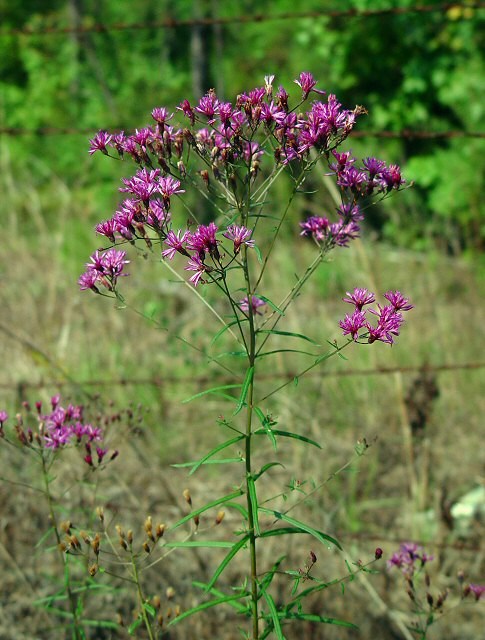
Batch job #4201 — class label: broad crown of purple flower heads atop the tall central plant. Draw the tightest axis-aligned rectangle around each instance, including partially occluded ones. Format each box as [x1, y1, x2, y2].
[86, 72, 404, 291]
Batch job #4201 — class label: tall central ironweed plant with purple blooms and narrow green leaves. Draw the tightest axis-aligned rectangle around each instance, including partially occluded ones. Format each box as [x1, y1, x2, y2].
[79, 72, 412, 640]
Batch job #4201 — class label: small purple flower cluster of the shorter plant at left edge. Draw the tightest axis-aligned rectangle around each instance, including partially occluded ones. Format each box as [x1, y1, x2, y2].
[0, 395, 118, 467]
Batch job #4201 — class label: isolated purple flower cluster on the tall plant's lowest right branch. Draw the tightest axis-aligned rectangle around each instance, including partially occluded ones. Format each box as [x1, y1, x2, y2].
[339, 288, 413, 345]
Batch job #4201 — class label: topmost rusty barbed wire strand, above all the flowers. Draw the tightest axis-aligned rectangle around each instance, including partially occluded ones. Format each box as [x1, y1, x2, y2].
[0, 2, 485, 36]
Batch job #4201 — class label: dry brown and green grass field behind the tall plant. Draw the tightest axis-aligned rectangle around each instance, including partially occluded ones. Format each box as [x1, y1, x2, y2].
[0, 203, 485, 640]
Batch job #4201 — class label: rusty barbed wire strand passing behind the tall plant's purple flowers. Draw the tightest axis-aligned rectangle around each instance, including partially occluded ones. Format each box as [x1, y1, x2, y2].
[0, 126, 485, 140]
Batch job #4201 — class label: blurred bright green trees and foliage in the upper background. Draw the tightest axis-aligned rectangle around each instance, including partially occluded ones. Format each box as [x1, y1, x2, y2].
[0, 0, 485, 254]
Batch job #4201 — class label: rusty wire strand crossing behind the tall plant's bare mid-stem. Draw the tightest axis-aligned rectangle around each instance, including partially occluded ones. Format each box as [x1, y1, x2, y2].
[0, 362, 485, 390]
